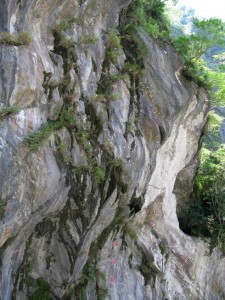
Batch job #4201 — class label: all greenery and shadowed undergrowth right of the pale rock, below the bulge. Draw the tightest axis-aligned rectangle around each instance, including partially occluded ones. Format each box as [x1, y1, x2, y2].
[180, 112, 225, 252]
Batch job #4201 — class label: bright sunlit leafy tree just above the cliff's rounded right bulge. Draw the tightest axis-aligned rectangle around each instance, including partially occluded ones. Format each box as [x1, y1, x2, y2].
[173, 14, 225, 106]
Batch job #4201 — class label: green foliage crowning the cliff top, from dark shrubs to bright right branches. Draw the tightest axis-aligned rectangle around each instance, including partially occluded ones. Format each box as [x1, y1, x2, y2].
[125, 0, 225, 106]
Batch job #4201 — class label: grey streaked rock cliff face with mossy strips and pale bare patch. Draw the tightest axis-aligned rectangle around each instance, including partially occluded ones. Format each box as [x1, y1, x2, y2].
[0, 0, 225, 300]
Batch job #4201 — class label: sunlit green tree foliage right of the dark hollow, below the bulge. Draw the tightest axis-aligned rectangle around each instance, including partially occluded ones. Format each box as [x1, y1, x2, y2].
[194, 146, 225, 251]
